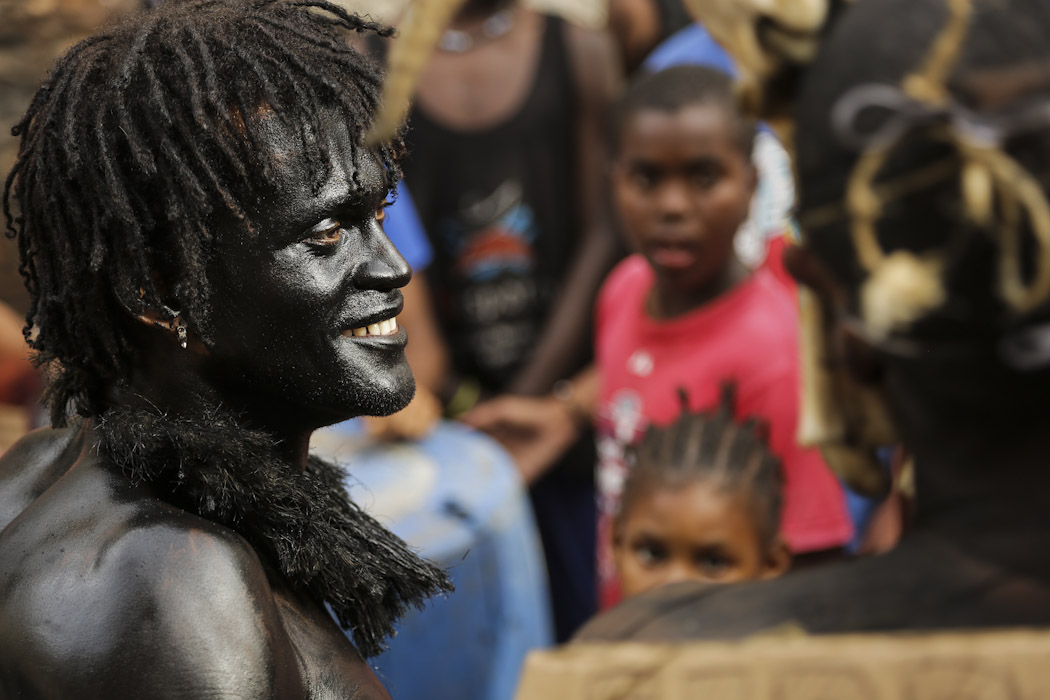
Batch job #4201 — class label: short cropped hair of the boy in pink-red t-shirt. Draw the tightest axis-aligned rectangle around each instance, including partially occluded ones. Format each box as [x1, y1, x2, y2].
[609, 65, 757, 157]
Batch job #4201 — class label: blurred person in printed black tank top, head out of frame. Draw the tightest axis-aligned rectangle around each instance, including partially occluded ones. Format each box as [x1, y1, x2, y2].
[394, 0, 618, 640]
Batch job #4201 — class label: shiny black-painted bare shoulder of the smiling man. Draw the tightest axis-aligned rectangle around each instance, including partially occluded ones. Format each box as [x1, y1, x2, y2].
[0, 464, 307, 700]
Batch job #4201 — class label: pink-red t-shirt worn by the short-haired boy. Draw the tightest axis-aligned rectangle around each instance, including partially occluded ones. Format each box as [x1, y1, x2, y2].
[595, 255, 853, 603]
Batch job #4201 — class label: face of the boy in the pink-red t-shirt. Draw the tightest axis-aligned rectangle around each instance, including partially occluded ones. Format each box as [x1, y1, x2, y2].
[613, 104, 755, 294]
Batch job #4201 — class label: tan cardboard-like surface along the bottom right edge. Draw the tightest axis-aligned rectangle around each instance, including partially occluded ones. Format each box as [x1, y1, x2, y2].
[516, 631, 1050, 700]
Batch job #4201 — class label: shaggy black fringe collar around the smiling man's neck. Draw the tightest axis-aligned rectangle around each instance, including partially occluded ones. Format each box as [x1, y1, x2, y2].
[96, 398, 452, 657]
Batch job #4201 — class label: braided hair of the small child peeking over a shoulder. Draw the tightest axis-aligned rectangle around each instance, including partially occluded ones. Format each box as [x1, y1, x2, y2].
[620, 381, 783, 545]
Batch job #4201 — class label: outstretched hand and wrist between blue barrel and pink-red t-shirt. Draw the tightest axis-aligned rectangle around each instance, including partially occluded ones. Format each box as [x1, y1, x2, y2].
[462, 365, 599, 484]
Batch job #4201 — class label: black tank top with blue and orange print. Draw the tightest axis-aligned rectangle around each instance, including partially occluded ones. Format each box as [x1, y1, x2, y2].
[404, 17, 580, 391]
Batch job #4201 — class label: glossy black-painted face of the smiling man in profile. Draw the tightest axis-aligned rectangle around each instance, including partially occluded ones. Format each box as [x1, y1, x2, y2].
[206, 110, 415, 428]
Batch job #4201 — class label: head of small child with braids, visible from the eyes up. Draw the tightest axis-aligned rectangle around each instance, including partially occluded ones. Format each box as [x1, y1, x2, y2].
[613, 382, 791, 598]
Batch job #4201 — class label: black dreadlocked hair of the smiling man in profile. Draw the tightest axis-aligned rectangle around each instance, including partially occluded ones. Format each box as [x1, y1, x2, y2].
[3, 0, 403, 425]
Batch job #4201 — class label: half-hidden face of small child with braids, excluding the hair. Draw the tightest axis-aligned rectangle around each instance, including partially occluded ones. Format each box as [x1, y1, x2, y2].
[613, 481, 791, 598]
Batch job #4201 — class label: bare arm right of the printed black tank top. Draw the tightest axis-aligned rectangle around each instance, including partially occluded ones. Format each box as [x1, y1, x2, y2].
[507, 25, 622, 396]
